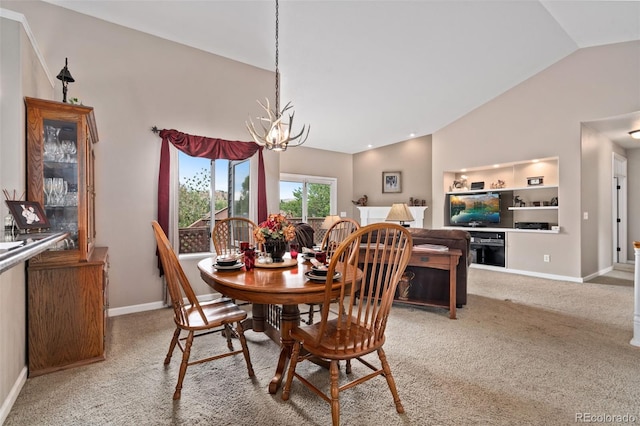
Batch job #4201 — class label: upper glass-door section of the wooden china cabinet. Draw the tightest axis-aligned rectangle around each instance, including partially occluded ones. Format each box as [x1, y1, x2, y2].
[25, 98, 97, 262]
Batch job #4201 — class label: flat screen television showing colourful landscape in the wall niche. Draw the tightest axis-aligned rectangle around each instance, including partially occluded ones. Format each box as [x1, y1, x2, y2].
[449, 192, 500, 226]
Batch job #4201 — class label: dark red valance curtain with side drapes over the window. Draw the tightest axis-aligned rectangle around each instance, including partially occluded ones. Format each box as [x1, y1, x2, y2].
[158, 129, 267, 241]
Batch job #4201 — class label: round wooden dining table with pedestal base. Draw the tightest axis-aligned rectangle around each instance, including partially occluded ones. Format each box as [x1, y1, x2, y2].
[198, 257, 362, 394]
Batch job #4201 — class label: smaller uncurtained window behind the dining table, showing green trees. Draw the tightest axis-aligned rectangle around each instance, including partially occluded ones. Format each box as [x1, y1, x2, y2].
[280, 173, 338, 242]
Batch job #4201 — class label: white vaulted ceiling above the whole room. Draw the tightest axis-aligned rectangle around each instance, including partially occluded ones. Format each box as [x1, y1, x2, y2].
[41, 0, 640, 153]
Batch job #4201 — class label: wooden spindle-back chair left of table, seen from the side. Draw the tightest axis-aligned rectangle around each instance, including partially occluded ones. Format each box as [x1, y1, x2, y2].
[152, 221, 254, 399]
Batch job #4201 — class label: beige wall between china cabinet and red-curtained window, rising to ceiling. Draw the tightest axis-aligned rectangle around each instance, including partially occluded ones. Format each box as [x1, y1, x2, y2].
[3, 1, 278, 309]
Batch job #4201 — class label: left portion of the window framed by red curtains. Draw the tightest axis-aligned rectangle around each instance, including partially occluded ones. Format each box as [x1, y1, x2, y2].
[177, 151, 230, 254]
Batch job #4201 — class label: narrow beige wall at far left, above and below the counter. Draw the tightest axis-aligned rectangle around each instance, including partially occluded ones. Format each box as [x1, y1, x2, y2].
[0, 11, 53, 423]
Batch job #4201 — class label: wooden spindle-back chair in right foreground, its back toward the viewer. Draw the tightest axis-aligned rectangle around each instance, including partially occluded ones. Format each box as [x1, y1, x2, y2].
[282, 223, 412, 426]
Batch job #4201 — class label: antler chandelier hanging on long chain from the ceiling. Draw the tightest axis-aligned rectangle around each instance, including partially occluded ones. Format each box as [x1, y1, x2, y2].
[246, 0, 311, 151]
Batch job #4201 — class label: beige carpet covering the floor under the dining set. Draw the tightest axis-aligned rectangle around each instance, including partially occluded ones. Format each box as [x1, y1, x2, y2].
[6, 269, 640, 426]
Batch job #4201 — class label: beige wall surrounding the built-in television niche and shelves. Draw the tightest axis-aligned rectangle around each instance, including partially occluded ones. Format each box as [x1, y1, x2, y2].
[433, 42, 640, 279]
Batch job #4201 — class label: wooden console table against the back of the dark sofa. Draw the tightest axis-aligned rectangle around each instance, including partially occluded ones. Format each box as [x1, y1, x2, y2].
[394, 247, 462, 319]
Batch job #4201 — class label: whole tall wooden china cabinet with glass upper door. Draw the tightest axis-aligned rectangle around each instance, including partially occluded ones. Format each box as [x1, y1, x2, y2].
[25, 98, 109, 377]
